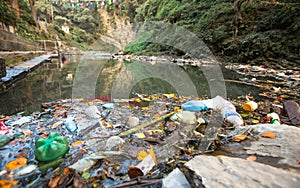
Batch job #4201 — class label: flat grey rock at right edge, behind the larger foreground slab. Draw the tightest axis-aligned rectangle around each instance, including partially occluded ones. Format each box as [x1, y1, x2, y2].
[243, 124, 300, 168]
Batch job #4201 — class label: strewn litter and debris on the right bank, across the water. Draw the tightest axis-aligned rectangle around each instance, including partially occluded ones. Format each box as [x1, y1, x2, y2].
[226, 64, 300, 100]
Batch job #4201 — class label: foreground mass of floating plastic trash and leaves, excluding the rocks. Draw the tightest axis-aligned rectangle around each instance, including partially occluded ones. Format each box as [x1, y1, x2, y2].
[0, 94, 300, 187]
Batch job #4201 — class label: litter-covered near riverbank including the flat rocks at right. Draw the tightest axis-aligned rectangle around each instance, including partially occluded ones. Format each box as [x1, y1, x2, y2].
[0, 94, 300, 187]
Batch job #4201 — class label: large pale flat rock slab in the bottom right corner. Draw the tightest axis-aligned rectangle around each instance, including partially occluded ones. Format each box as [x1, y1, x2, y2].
[184, 155, 300, 188]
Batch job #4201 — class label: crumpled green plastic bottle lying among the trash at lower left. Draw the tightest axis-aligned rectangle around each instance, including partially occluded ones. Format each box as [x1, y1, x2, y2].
[35, 132, 69, 162]
